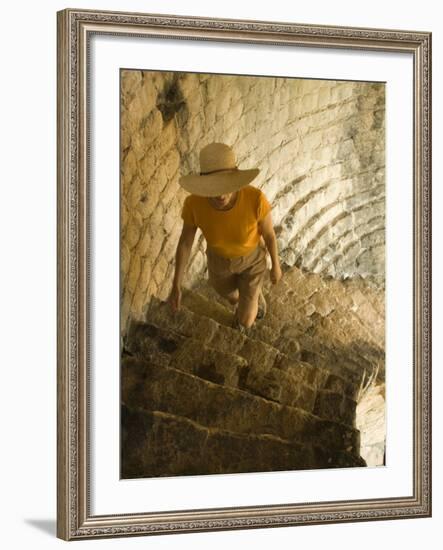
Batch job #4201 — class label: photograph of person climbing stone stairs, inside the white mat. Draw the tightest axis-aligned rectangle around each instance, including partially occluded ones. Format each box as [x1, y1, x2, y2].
[120, 68, 389, 479]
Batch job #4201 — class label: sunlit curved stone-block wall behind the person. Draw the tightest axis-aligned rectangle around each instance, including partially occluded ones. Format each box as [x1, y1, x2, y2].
[121, 70, 385, 334]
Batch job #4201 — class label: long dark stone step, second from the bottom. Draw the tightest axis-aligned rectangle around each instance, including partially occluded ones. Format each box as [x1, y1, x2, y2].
[122, 357, 360, 455]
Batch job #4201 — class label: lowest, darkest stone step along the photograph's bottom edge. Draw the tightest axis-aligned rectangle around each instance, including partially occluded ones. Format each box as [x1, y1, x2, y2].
[121, 406, 365, 479]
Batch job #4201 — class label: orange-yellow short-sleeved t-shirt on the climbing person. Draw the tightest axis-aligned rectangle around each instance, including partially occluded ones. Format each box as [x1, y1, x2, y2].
[182, 185, 271, 258]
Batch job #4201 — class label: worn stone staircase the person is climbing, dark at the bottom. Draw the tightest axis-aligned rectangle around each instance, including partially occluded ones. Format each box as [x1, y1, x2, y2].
[121, 268, 384, 478]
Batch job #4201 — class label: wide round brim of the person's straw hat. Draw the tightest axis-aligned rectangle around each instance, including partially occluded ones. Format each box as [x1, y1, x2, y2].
[179, 168, 260, 201]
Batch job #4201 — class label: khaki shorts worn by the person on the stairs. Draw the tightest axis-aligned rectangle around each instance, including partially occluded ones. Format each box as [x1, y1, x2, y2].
[206, 245, 266, 299]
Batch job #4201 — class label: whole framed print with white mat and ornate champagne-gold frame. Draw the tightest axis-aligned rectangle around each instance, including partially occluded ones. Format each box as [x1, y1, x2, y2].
[58, 9, 431, 540]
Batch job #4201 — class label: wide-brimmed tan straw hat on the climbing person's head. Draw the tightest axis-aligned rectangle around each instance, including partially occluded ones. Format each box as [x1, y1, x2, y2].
[179, 143, 260, 197]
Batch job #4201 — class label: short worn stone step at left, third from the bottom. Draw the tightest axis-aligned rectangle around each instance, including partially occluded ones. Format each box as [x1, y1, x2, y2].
[125, 321, 248, 388]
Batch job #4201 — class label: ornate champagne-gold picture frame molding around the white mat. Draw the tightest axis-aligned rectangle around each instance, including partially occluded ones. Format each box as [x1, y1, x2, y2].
[57, 9, 431, 540]
